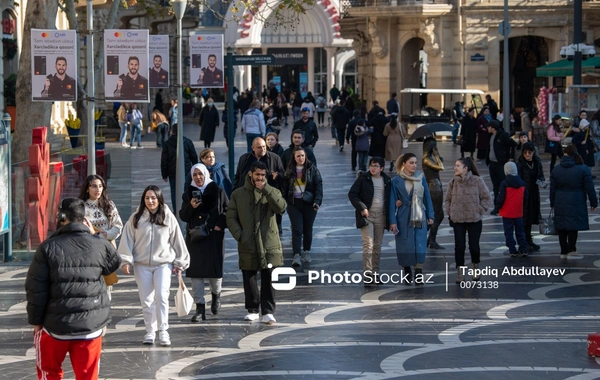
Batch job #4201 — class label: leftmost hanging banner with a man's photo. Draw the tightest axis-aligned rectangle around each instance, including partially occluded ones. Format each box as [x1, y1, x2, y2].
[31, 29, 77, 102]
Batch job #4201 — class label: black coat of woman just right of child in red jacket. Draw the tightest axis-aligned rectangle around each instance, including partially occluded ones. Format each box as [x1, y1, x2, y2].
[517, 155, 546, 225]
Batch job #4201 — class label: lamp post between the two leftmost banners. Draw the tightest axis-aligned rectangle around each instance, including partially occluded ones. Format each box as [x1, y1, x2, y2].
[87, 0, 96, 175]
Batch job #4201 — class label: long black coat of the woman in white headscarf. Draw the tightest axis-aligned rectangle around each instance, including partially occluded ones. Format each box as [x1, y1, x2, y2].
[179, 182, 229, 278]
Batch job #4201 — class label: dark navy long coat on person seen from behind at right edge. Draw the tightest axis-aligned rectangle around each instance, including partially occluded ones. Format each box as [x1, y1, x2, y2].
[550, 156, 598, 231]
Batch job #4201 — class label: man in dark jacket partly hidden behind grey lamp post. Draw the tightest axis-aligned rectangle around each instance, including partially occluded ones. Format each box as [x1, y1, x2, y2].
[160, 124, 198, 212]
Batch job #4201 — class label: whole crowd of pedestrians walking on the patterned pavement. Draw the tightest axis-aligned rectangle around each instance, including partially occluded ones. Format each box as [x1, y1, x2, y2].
[26, 87, 600, 375]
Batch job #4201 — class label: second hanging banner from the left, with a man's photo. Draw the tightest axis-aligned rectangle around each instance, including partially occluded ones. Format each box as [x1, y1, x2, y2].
[104, 29, 150, 103]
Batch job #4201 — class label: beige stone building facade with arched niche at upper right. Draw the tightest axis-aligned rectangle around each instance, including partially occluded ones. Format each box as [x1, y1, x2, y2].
[340, 0, 600, 114]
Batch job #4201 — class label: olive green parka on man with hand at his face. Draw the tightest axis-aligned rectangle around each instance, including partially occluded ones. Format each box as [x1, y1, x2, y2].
[227, 176, 287, 270]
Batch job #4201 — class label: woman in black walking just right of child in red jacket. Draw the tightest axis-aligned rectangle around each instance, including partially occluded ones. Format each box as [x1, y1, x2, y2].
[517, 142, 546, 251]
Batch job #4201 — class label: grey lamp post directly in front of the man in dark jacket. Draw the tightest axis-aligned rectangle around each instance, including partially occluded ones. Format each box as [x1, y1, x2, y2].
[171, 0, 187, 222]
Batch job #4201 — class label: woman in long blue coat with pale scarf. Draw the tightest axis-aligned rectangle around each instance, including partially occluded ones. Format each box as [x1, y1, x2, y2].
[388, 153, 434, 285]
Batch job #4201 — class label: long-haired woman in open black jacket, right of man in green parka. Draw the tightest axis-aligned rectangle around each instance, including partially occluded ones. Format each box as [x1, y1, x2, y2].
[282, 147, 323, 267]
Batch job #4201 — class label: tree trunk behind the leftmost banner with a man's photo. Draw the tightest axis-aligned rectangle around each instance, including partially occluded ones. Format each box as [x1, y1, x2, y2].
[12, 0, 58, 162]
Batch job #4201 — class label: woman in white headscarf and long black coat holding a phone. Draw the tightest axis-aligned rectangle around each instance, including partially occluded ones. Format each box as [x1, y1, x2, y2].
[179, 164, 229, 322]
